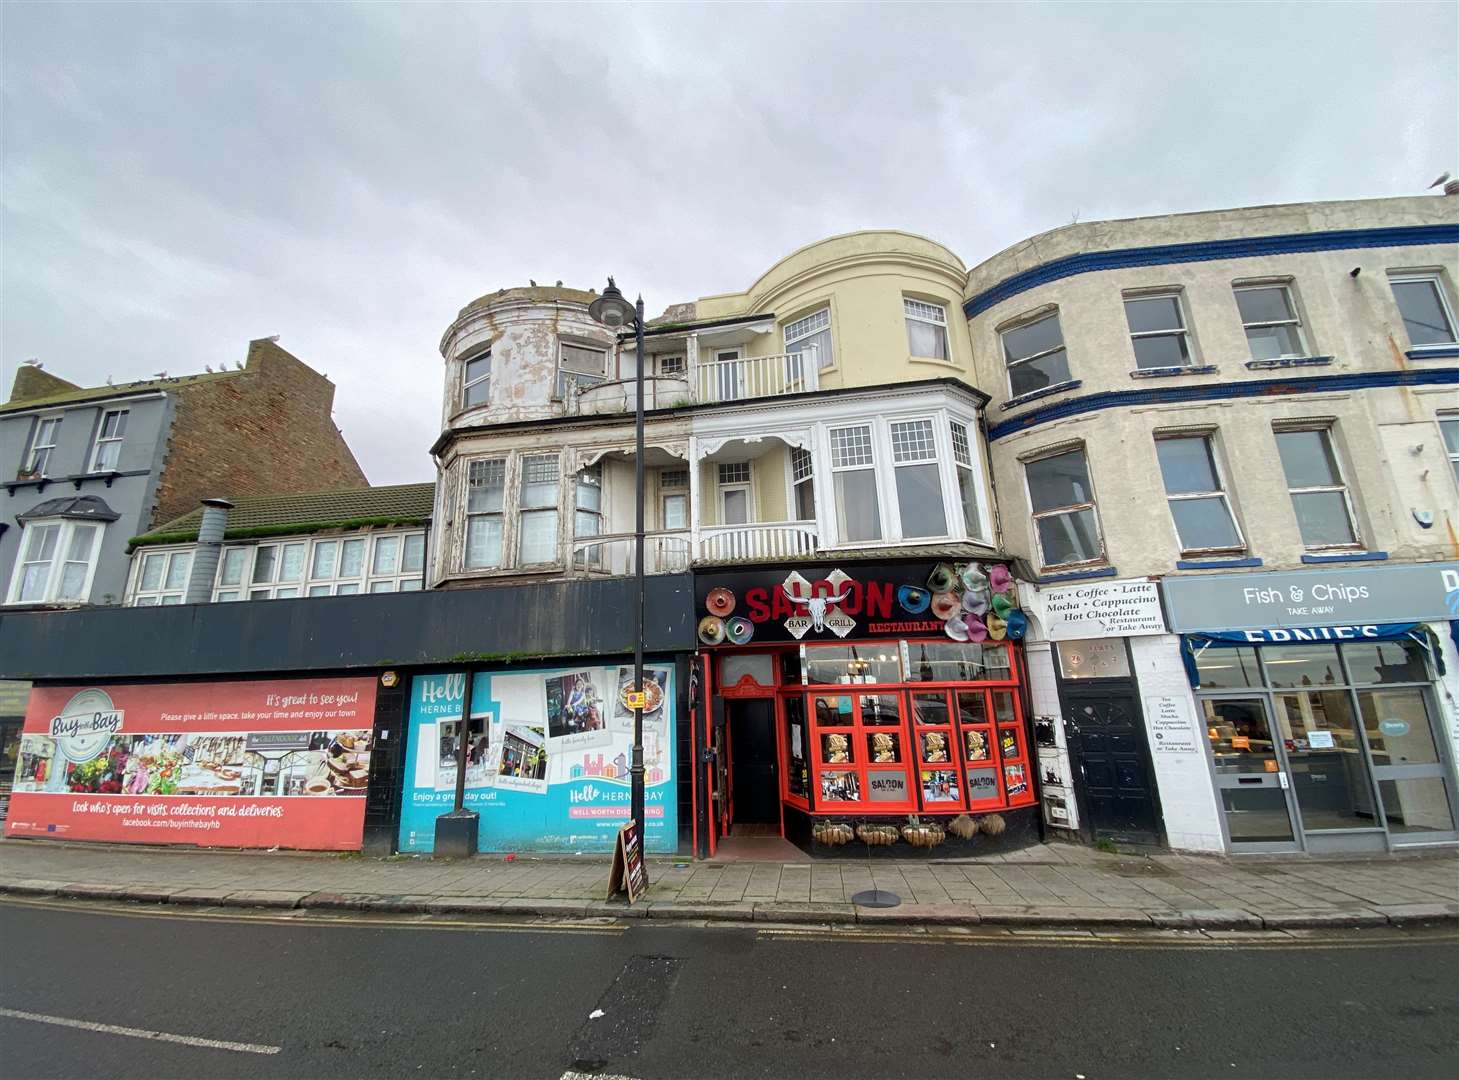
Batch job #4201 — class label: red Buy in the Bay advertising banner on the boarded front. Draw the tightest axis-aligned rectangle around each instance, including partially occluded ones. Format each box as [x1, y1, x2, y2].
[4, 679, 375, 851]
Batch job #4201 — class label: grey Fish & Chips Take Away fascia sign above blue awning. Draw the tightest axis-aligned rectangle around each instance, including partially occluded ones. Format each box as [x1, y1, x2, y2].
[1161, 562, 1459, 633]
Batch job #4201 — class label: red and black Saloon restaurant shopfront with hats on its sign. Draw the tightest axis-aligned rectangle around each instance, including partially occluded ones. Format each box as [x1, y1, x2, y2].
[696, 562, 1039, 857]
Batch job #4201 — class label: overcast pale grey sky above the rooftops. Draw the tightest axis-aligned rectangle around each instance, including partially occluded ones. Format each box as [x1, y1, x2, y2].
[0, 0, 1459, 483]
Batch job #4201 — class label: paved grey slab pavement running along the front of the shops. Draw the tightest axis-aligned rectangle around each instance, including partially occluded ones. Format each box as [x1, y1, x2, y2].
[0, 839, 1459, 930]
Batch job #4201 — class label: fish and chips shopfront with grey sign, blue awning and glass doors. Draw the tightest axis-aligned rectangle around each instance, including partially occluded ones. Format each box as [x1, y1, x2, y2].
[1164, 563, 1459, 852]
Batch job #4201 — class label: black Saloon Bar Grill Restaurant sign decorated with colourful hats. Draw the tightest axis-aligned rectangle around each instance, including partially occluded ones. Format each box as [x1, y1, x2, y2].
[694, 562, 1027, 645]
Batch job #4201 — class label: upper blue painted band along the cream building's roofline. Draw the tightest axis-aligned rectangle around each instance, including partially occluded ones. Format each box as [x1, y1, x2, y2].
[963, 225, 1459, 318]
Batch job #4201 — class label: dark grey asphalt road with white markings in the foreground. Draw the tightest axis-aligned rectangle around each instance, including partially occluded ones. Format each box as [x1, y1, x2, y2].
[0, 903, 1459, 1080]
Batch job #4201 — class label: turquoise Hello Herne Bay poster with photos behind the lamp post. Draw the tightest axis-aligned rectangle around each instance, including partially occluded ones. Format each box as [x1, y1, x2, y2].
[400, 664, 678, 854]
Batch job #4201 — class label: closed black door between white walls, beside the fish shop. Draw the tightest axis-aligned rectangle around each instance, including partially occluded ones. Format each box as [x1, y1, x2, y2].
[1059, 679, 1160, 844]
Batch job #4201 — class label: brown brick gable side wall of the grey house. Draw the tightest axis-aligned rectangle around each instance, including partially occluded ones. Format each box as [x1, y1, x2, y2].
[152, 340, 369, 525]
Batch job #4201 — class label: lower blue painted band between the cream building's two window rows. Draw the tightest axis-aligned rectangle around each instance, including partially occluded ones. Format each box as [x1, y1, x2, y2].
[988, 368, 1459, 442]
